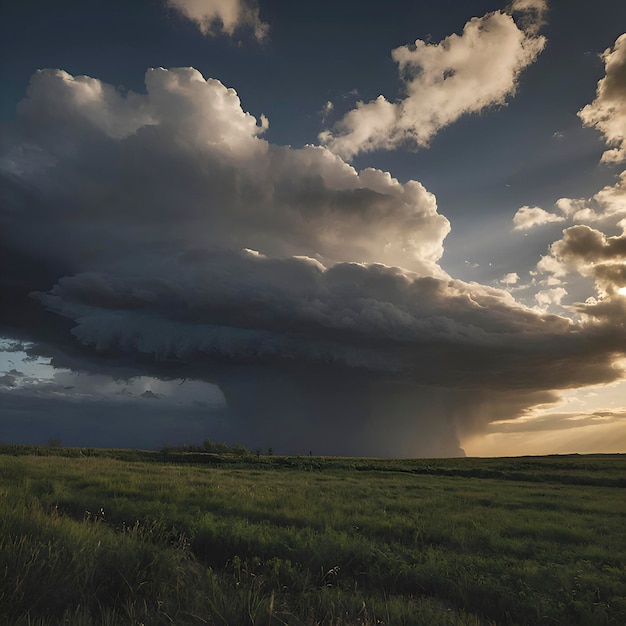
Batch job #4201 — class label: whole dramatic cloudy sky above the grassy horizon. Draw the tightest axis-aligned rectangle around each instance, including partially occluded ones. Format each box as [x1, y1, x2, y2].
[0, 0, 626, 457]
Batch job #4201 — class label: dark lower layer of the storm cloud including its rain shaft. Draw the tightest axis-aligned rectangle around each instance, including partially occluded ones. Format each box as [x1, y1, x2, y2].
[22, 253, 620, 456]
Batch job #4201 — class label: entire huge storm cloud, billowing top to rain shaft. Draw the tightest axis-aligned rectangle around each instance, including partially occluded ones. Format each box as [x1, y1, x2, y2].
[0, 62, 626, 456]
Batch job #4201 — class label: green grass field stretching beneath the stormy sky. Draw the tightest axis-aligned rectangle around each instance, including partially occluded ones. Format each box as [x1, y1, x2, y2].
[0, 446, 626, 626]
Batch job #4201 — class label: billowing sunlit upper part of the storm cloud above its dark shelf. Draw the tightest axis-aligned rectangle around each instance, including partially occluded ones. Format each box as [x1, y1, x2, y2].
[2, 68, 450, 275]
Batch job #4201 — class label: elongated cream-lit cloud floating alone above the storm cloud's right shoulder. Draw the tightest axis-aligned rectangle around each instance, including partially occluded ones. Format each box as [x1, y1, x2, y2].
[319, 7, 545, 159]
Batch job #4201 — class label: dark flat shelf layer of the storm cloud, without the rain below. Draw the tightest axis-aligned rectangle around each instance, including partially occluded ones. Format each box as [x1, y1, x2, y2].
[33, 252, 588, 378]
